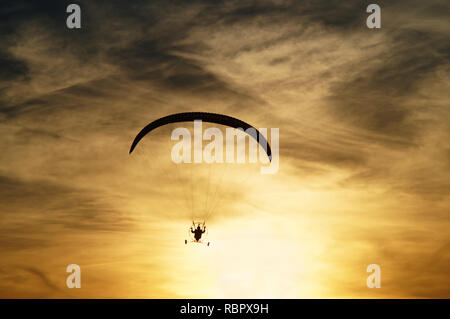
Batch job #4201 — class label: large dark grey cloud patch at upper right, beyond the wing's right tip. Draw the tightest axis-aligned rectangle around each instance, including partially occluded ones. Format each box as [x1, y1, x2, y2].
[329, 10, 450, 146]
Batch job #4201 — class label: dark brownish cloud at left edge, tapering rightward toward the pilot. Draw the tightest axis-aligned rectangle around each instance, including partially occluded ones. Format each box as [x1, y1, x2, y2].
[0, 176, 134, 236]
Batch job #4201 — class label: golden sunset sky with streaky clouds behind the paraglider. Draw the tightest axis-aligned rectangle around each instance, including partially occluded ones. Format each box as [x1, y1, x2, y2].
[0, 0, 450, 298]
